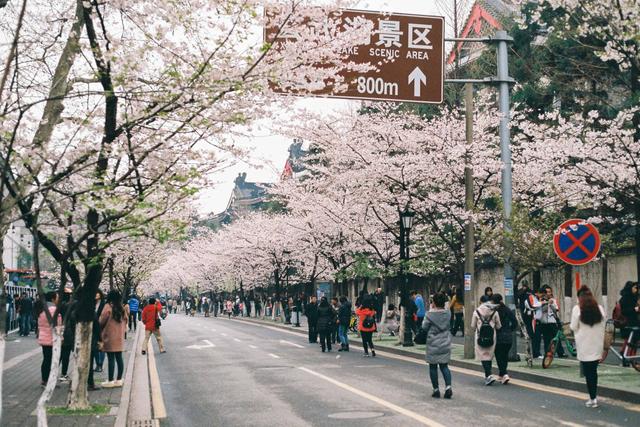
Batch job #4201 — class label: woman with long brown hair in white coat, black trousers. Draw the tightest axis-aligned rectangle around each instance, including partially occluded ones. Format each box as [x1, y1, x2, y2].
[570, 286, 606, 408]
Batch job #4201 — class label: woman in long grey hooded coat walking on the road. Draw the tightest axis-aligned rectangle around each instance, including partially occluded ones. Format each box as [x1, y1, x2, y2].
[421, 292, 453, 399]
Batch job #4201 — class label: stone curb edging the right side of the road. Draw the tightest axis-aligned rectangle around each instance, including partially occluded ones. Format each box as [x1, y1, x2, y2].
[232, 317, 640, 403]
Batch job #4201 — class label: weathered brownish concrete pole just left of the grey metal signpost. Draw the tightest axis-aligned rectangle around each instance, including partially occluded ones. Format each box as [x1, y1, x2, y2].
[463, 83, 476, 359]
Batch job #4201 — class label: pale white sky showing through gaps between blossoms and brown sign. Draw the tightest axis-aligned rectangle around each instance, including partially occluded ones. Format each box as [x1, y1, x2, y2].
[198, 0, 452, 215]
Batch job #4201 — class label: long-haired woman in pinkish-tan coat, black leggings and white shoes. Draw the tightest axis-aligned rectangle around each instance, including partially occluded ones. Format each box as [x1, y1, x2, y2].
[100, 290, 128, 388]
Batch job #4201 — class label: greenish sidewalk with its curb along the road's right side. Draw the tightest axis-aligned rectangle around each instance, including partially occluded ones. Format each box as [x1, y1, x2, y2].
[228, 317, 640, 403]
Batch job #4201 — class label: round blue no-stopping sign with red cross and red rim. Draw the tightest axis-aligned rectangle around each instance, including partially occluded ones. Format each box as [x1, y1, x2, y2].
[553, 219, 600, 265]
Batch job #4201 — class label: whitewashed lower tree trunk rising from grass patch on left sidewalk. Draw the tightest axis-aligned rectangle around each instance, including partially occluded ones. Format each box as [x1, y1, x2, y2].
[67, 322, 93, 409]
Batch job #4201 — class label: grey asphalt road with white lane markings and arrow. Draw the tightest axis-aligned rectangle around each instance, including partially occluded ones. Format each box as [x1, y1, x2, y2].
[152, 314, 640, 427]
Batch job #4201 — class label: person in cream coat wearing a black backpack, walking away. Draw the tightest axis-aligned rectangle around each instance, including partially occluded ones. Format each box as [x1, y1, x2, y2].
[471, 301, 502, 386]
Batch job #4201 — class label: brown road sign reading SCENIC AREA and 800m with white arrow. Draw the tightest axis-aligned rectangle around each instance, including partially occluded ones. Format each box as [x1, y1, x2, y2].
[265, 10, 444, 103]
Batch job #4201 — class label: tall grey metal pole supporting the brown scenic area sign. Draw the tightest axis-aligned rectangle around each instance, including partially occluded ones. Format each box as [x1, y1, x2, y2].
[495, 31, 517, 360]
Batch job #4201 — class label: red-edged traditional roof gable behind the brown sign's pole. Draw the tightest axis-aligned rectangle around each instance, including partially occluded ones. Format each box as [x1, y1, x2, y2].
[447, 0, 519, 65]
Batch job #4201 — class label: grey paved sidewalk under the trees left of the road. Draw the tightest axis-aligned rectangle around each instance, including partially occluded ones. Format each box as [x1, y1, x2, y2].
[2, 326, 141, 427]
